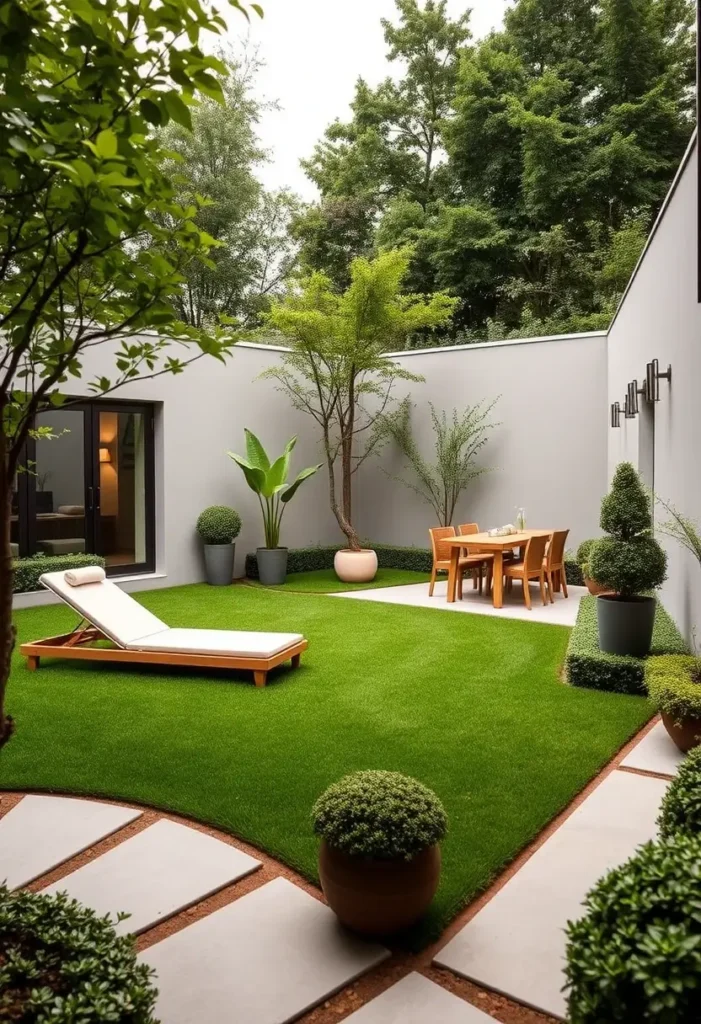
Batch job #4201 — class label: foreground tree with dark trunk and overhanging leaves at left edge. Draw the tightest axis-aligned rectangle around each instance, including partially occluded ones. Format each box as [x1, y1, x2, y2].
[0, 0, 261, 742]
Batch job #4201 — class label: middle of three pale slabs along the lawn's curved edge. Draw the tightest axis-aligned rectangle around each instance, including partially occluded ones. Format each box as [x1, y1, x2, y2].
[44, 818, 261, 935]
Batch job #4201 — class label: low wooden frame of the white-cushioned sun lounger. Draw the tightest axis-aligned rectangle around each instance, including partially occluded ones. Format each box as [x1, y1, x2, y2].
[19, 573, 308, 686]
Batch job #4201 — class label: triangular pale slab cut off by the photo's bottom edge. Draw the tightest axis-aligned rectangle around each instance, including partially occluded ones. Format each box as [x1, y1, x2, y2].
[344, 974, 494, 1024]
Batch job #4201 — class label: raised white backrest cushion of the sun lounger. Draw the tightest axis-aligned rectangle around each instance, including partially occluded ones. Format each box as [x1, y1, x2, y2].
[39, 572, 168, 647]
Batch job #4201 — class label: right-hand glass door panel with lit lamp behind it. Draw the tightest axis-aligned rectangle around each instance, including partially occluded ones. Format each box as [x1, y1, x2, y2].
[95, 406, 152, 572]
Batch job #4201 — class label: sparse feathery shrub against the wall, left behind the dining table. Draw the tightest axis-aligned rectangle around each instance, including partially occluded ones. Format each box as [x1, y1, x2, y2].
[381, 398, 498, 526]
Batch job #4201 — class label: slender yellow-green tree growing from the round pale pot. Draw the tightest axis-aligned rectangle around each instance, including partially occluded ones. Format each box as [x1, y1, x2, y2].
[264, 250, 454, 551]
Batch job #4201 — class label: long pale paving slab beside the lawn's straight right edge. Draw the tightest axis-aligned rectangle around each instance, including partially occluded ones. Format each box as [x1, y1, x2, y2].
[435, 771, 668, 1019]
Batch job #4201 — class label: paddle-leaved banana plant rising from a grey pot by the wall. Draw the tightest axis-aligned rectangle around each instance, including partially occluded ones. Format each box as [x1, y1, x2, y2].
[226, 428, 321, 548]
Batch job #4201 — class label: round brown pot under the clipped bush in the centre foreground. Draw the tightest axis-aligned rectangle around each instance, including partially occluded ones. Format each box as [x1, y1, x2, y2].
[319, 840, 441, 936]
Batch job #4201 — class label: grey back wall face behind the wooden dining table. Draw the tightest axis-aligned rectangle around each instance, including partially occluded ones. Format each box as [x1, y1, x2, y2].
[356, 334, 607, 548]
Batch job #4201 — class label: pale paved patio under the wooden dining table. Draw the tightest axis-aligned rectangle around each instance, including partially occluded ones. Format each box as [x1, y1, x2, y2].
[330, 580, 589, 628]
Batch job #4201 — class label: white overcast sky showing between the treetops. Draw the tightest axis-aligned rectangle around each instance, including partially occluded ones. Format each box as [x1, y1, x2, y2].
[220, 0, 508, 200]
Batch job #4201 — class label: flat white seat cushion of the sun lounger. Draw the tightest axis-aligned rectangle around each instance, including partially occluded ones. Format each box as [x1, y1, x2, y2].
[127, 629, 304, 658]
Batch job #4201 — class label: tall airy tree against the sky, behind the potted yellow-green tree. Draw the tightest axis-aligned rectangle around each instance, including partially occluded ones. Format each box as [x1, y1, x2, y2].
[297, 0, 470, 287]
